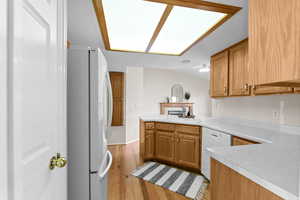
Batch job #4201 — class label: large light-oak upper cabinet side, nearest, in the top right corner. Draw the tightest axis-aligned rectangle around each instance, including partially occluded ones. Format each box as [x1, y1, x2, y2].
[249, 0, 300, 86]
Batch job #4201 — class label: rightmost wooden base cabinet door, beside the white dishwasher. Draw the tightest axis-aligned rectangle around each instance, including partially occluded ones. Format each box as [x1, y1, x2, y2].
[175, 133, 201, 169]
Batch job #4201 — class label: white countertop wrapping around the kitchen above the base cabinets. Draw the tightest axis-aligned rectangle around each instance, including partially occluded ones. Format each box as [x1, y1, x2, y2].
[141, 115, 300, 200]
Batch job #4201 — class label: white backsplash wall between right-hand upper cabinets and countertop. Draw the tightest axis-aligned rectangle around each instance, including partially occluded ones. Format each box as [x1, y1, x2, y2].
[212, 94, 300, 126]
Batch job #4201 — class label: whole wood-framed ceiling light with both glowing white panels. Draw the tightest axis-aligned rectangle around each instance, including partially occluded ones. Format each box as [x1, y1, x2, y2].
[93, 0, 240, 55]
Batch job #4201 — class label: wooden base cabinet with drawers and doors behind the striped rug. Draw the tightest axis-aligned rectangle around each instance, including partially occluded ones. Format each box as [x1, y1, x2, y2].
[140, 121, 202, 171]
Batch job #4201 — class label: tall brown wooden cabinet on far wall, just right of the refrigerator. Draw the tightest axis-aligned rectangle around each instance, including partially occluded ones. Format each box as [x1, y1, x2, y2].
[109, 72, 124, 126]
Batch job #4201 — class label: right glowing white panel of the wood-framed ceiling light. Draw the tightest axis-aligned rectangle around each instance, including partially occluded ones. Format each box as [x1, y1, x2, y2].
[150, 6, 227, 55]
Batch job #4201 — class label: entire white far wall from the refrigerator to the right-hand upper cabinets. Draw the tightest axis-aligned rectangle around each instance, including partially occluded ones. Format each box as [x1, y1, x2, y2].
[108, 67, 211, 144]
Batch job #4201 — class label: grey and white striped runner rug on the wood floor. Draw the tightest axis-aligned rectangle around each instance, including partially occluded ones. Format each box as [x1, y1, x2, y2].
[132, 162, 207, 200]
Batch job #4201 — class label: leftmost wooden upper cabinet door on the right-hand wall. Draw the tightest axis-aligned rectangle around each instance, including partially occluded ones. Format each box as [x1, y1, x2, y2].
[210, 51, 228, 97]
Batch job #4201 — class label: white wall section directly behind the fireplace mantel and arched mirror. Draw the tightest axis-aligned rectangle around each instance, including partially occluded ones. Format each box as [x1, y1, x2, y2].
[142, 68, 211, 118]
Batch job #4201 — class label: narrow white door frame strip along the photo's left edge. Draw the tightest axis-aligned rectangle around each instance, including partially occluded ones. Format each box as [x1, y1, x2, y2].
[0, 0, 8, 200]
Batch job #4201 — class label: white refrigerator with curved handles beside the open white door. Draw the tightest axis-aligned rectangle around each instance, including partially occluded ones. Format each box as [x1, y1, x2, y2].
[67, 47, 112, 200]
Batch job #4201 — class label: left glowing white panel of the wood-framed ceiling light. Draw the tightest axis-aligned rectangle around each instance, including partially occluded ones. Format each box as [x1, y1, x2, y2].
[102, 0, 166, 52]
